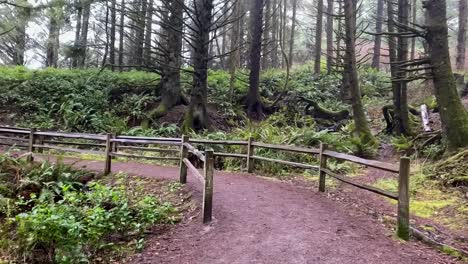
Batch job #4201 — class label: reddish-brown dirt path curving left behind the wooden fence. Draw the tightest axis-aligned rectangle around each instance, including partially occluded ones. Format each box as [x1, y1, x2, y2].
[37, 158, 457, 264]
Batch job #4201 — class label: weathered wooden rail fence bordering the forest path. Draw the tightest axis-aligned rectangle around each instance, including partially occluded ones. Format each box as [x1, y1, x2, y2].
[0, 127, 410, 239]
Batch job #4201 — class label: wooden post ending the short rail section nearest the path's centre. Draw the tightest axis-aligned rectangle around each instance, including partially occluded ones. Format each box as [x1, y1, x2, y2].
[203, 150, 214, 224]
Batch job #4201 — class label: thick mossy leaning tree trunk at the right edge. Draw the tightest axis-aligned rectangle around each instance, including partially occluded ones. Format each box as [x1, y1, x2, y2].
[424, 0, 468, 151]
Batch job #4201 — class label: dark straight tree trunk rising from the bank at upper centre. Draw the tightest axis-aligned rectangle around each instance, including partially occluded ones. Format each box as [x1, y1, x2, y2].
[247, 0, 266, 120]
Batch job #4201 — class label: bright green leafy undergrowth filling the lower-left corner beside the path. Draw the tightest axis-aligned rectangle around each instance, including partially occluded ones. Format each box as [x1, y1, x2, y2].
[0, 153, 178, 263]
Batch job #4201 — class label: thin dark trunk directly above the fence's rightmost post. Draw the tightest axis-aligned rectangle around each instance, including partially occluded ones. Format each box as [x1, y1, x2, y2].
[397, 0, 411, 135]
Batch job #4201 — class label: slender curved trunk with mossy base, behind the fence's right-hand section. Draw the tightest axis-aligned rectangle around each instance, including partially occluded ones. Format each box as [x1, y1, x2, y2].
[344, 0, 376, 145]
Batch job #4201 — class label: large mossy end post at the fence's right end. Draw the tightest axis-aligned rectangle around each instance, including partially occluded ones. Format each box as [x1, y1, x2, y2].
[397, 157, 410, 240]
